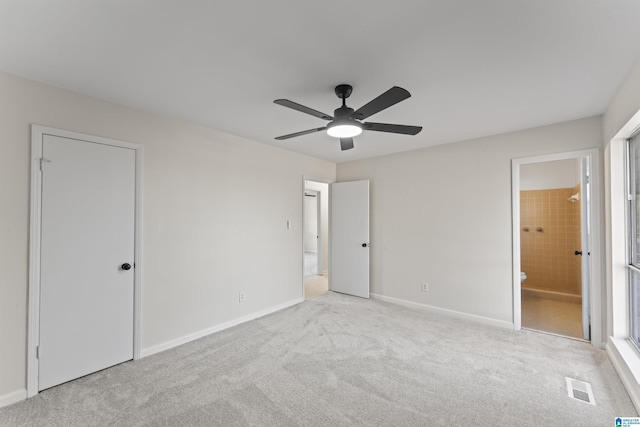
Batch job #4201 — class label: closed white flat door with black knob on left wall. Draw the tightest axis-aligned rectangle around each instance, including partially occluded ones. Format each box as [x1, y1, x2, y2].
[38, 135, 136, 390]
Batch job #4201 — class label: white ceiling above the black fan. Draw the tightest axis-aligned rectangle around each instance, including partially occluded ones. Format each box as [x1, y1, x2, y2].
[0, 0, 640, 163]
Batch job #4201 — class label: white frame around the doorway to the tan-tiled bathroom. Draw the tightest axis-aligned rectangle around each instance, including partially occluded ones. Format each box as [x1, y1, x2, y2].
[511, 148, 604, 348]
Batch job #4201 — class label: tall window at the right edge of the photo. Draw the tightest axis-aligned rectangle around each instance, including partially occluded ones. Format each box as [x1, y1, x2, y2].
[627, 134, 640, 348]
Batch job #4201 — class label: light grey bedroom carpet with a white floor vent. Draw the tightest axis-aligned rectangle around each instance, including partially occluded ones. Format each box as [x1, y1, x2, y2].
[0, 292, 636, 427]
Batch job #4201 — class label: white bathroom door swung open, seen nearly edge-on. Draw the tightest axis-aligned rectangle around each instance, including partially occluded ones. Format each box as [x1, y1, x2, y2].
[580, 157, 591, 340]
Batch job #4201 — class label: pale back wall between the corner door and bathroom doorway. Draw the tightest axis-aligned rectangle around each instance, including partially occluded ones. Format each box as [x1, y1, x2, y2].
[337, 117, 602, 322]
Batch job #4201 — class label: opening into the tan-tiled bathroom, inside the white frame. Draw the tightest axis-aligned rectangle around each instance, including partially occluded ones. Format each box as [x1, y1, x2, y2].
[520, 158, 590, 340]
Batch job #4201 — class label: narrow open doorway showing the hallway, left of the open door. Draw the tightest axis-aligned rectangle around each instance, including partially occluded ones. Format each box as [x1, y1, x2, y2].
[303, 180, 329, 299]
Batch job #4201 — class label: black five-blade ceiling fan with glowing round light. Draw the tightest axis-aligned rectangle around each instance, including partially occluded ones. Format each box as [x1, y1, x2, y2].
[273, 84, 422, 150]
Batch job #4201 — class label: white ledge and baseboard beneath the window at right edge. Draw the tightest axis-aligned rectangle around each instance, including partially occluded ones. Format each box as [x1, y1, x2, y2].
[605, 337, 640, 413]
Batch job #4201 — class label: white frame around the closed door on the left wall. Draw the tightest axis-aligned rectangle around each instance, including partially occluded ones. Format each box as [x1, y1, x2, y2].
[27, 125, 142, 397]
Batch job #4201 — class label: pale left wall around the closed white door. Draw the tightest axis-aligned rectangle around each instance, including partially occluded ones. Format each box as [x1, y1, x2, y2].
[0, 72, 335, 400]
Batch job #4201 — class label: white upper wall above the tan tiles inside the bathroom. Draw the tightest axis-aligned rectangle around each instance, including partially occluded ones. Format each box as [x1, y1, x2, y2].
[520, 159, 580, 191]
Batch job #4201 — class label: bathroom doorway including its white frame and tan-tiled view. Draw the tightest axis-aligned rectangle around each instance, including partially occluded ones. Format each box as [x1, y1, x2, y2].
[513, 152, 600, 341]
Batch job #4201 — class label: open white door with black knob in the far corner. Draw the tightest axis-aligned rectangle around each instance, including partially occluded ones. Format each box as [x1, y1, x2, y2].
[329, 181, 369, 298]
